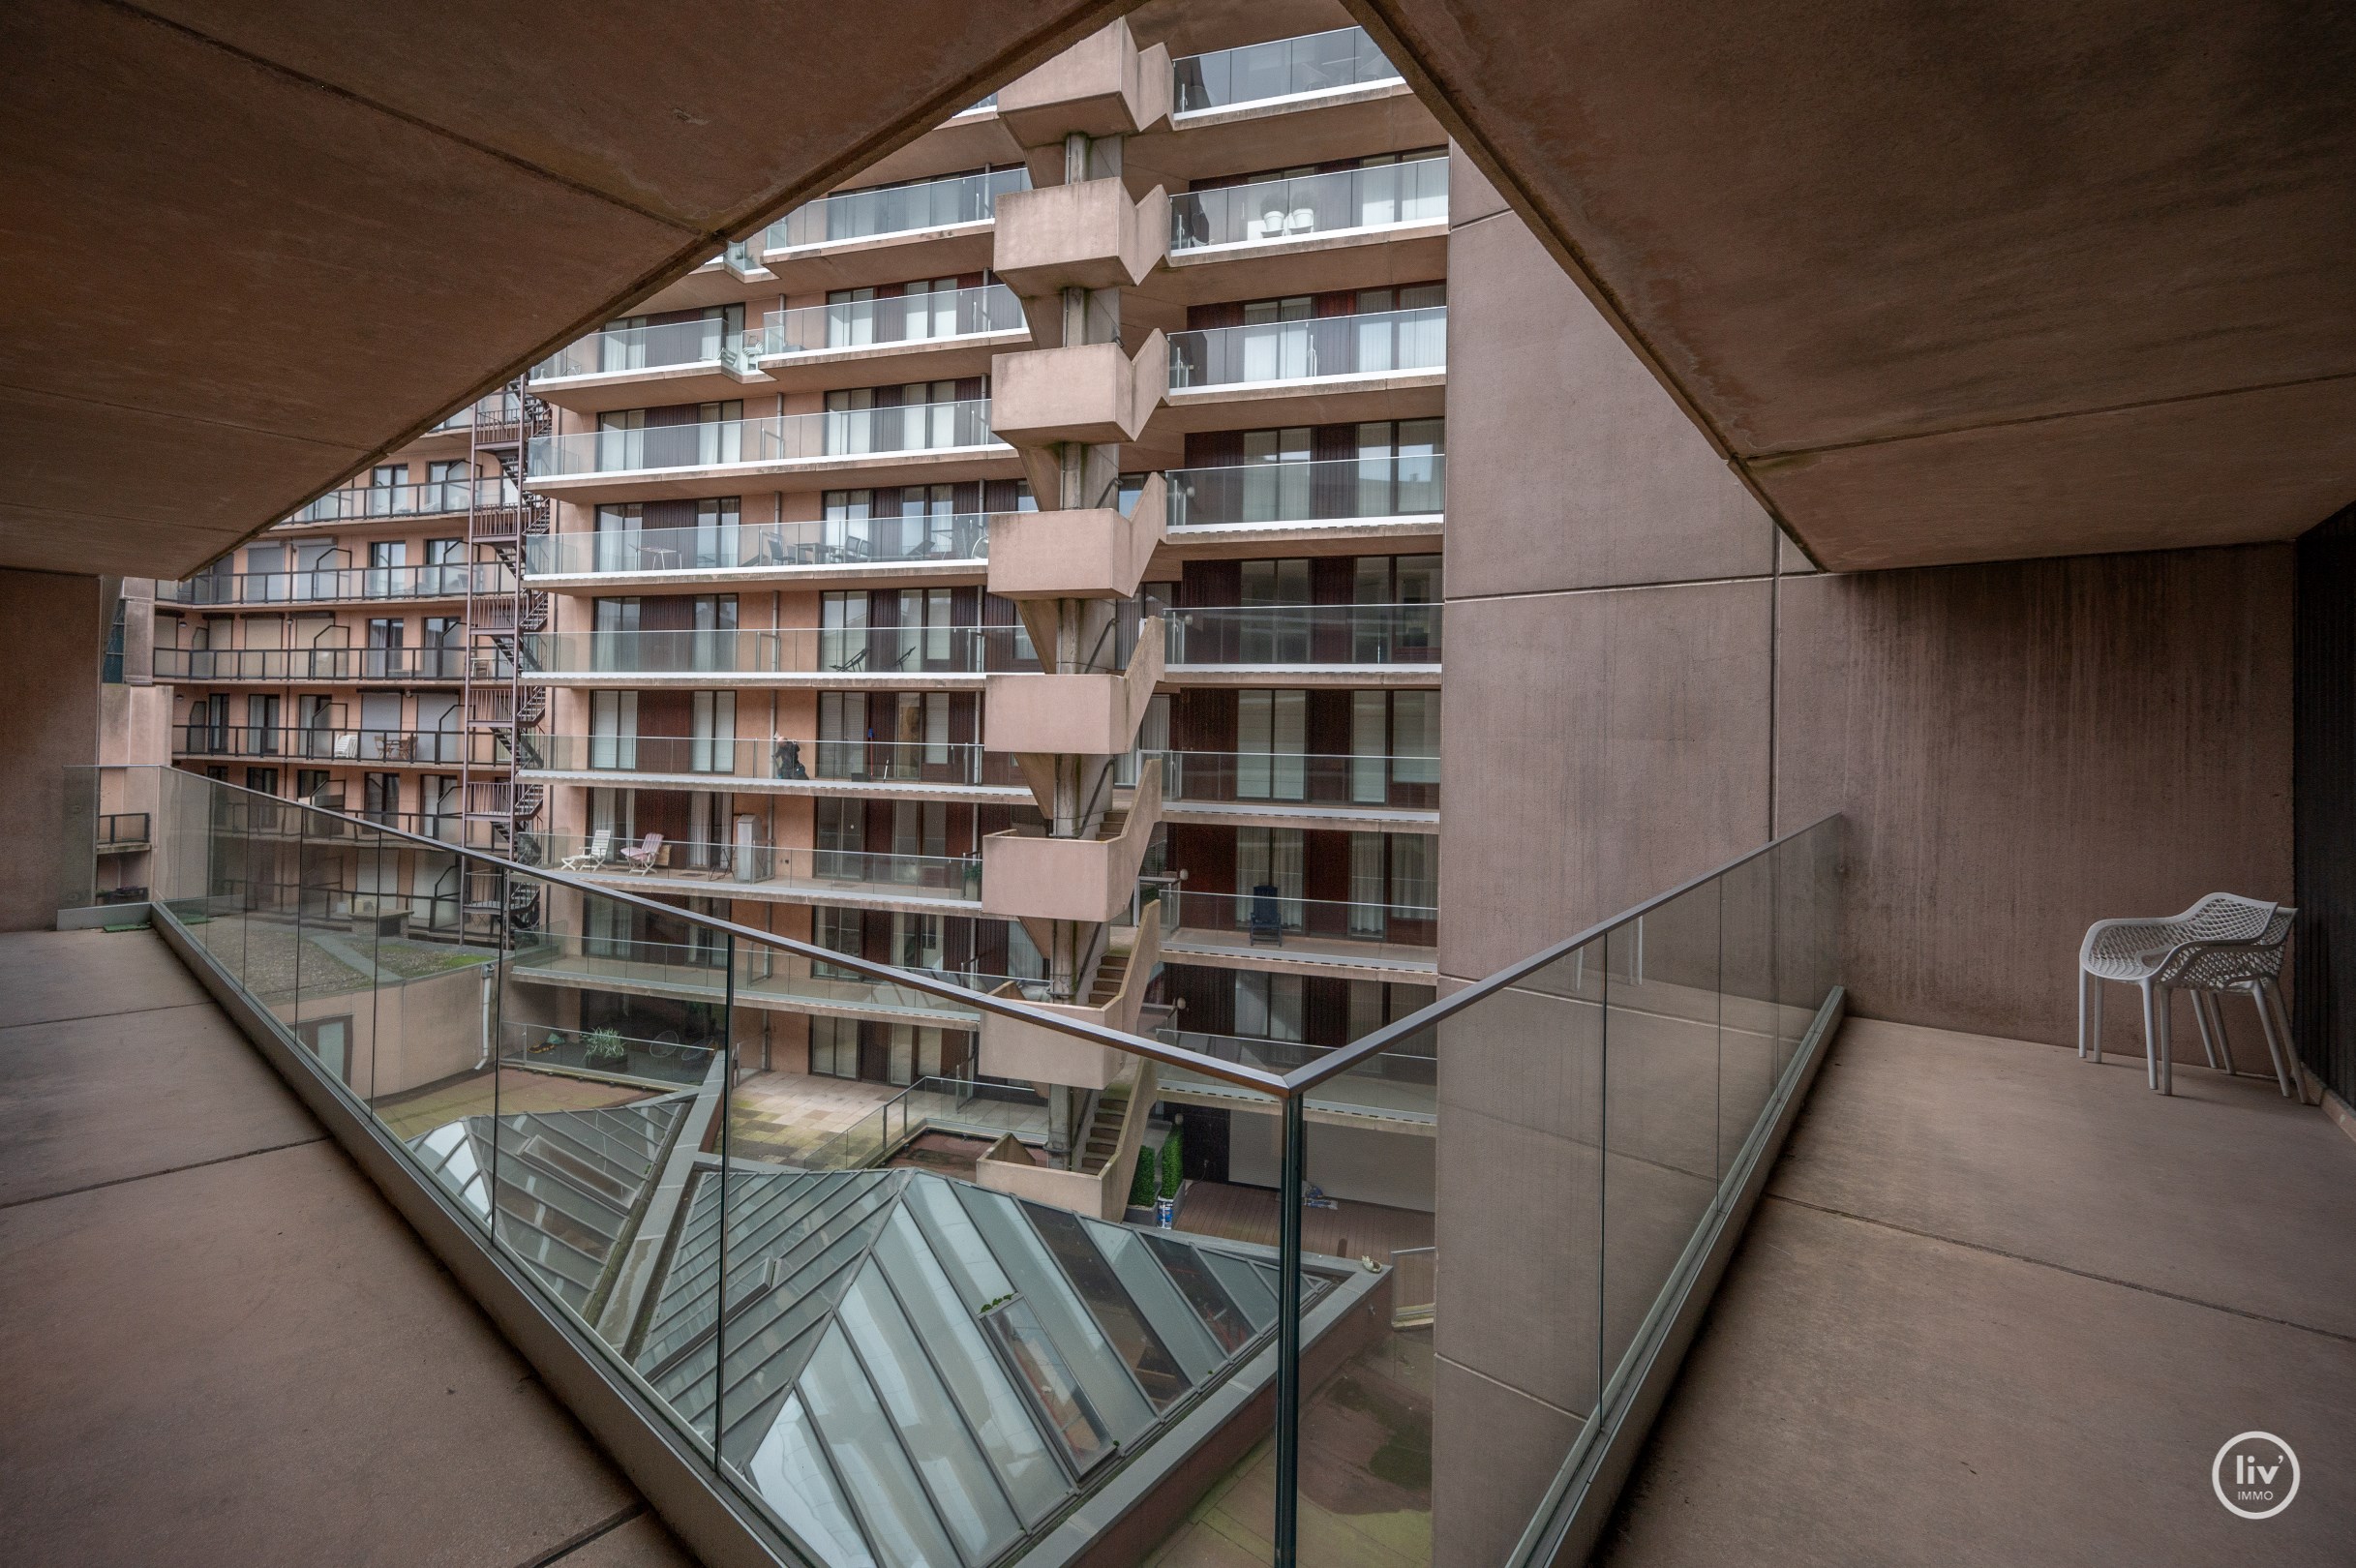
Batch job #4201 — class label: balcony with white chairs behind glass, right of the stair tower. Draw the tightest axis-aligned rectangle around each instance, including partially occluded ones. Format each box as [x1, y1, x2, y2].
[1168, 158, 1449, 304]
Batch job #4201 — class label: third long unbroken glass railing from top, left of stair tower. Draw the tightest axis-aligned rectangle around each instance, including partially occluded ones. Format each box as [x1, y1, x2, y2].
[523, 626, 1041, 676]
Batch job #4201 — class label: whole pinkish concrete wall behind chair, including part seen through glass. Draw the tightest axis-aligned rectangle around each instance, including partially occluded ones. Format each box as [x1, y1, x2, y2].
[1423, 146, 2292, 1566]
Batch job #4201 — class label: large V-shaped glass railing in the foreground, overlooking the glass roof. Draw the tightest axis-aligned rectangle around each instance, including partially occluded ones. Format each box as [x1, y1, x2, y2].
[66, 769, 1842, 1568]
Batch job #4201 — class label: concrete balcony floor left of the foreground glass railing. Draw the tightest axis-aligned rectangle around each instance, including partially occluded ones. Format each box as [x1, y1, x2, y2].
[0, 932, 693, 1568]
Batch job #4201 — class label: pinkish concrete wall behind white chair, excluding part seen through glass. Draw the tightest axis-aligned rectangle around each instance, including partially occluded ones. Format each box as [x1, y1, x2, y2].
[1439, 146, 2290, 1043]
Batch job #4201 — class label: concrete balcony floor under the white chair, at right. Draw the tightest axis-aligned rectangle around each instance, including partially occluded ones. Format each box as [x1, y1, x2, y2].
[1597, 1012, 2356, 1568]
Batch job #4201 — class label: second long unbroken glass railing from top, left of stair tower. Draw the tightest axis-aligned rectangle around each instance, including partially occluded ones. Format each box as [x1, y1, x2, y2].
[523, 511, 1013, 577]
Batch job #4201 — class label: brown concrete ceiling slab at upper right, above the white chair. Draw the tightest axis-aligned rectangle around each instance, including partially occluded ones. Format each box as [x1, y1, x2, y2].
[1347, 0, 2356, 570]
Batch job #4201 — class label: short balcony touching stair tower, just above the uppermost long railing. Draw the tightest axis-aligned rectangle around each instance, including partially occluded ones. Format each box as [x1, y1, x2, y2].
[742, 283, 1030, 391]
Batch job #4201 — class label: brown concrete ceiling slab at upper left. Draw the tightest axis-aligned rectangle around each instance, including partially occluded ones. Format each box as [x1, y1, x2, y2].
[0, 0, 1124, 577]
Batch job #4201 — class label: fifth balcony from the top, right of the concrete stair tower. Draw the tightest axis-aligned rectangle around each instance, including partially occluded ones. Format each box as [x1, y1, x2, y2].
[1163, 605, 1439, 685]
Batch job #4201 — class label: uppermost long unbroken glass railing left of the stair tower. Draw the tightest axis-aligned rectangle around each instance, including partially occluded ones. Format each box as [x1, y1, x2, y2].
[530, 398, 1011, 478]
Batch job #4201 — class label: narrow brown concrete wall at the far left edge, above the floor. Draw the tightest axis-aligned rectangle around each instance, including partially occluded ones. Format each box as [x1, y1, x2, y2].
[0, 572, 113, 930]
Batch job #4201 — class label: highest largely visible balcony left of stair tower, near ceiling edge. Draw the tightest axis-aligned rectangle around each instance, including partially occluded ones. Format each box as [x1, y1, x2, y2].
[751, 167, 1030, 294]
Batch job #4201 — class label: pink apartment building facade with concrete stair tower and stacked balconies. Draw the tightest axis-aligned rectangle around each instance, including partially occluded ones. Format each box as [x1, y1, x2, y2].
[516, 7, 1446, 1210]
